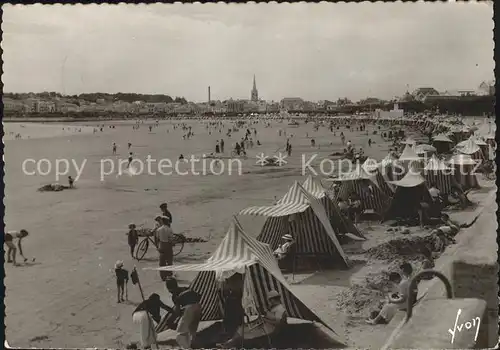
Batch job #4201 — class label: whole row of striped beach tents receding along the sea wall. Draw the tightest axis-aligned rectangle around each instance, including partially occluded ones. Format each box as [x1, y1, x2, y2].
[145, 115, 492, 348]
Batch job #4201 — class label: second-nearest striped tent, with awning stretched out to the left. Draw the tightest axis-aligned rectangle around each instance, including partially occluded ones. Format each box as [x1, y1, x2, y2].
[238, 181, 347, 266]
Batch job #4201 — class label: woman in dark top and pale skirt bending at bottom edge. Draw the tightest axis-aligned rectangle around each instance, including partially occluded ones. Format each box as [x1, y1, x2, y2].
[132, 293, 173, 349]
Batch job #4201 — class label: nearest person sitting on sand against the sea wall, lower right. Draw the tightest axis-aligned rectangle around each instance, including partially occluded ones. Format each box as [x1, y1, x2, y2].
[366, 272, 408, 324]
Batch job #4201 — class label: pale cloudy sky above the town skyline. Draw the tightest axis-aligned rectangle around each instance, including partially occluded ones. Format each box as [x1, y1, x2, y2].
[1, 2, 494, 102]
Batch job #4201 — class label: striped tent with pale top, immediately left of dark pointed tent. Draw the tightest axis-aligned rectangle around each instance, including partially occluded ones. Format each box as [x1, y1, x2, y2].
[334, 166, 390, 215]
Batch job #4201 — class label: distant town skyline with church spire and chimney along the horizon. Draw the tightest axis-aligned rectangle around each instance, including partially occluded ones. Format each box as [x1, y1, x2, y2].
[3, 76, 495, 117]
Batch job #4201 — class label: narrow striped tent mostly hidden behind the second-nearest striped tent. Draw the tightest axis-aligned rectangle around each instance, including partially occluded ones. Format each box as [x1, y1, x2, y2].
[302, 175, 365, 238]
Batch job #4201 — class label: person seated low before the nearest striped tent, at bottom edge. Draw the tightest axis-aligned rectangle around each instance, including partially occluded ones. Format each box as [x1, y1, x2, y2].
[217, 290, 287, 349]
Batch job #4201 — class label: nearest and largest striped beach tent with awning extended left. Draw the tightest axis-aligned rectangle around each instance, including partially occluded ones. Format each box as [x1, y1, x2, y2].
[150, 218, 344, 345]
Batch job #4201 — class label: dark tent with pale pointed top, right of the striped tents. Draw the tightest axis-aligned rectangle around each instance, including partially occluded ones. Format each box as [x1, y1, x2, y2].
[384, 168, 431, 220]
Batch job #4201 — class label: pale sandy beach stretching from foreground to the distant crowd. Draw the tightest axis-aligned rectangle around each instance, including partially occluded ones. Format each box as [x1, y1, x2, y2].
[4, 117, 494, 348]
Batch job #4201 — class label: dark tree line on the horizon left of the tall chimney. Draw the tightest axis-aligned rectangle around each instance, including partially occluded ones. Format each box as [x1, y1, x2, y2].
[3, 91, 188, 104]
